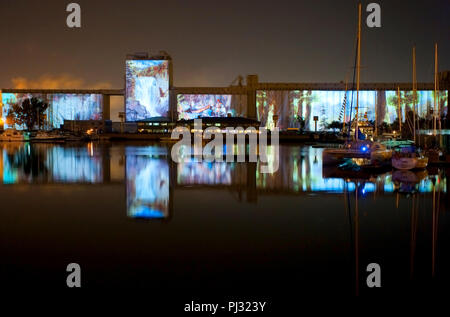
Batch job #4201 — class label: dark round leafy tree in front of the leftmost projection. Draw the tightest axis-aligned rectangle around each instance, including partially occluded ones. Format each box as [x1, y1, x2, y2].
[7, 97, 48, 131]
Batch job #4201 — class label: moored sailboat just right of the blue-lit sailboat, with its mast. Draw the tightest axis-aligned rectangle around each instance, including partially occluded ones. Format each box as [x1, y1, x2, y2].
[392, 46, 428, 170]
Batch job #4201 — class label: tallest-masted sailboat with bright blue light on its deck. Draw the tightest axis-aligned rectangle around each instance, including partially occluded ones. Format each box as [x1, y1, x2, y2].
[322, 3, 392, 167]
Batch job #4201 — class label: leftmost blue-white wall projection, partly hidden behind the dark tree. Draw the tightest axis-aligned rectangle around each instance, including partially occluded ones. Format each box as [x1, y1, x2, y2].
[2, 93, 103, 129]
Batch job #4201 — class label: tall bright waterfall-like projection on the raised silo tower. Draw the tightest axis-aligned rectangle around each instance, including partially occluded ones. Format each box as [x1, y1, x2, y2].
[125, 60, 169, 121]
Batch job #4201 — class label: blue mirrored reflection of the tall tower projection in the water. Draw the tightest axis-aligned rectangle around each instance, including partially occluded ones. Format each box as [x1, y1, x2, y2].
[126, 155, 170, 219]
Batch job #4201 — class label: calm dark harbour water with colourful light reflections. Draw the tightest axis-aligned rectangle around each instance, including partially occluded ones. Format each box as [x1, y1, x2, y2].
[0, 143, 450, 295]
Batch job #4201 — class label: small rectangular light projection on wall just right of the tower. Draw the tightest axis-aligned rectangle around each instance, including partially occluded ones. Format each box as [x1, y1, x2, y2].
[177, 94, 233, 120]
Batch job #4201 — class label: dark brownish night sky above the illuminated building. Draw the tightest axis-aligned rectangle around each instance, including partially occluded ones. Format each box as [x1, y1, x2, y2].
[0, 0, 450, 88]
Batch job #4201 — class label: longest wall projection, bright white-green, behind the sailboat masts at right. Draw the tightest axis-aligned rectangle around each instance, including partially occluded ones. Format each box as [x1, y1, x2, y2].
[256, 90, 448, 131]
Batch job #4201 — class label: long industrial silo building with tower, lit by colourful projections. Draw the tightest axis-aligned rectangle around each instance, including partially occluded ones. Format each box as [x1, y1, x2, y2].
[1, 52, 450, 133]
